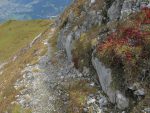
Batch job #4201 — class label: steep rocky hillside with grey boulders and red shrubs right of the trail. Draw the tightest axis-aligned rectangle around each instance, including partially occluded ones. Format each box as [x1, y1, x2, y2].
[50, 0, 150, 113]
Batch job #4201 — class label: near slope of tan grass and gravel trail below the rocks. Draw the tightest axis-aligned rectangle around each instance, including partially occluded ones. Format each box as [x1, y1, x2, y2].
[0, 23, 100, 113]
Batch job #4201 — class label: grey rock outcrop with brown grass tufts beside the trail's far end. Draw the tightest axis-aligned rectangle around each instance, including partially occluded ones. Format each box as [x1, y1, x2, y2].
[58, 0, 103, 61]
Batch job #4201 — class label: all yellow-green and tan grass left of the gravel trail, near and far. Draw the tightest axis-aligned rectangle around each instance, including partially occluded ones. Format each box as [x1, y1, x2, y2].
[0, 20, 52, 113]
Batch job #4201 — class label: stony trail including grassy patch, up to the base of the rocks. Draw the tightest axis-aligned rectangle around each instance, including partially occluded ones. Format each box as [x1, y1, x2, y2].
[13, 28, 105, 113]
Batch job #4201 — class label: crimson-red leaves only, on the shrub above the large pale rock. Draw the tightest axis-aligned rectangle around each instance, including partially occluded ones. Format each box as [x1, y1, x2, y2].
[98, 8, 150, 61]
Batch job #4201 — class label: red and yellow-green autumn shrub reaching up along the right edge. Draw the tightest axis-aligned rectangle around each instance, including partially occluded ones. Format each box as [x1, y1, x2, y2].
[97, 8, 150, 64]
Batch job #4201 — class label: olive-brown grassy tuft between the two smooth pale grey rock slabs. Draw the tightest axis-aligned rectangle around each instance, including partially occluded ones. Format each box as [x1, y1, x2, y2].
[72, 26, 99, 70]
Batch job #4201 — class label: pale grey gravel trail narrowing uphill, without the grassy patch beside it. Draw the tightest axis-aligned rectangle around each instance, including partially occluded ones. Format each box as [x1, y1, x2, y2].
[14, 29, 86, 113]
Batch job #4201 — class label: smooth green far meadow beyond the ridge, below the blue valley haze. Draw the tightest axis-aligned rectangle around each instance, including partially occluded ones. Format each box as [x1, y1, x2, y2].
[0, 20, 50, 62]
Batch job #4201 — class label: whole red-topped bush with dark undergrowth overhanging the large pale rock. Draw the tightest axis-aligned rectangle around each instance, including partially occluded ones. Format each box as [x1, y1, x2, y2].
[97, 8, 150, 85]
